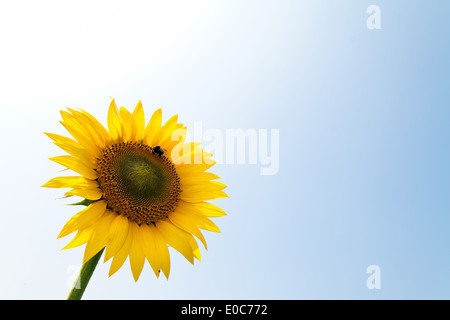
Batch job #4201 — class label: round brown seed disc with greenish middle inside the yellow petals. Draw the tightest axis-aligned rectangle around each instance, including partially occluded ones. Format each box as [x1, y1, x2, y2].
[97, 142, 181, 224]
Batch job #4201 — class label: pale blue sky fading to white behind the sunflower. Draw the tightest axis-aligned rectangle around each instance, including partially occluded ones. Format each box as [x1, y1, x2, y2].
[0, 0, 450, 299]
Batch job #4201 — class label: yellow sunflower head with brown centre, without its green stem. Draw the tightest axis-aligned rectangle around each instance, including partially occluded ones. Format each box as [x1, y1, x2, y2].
[43, 99, 228, 281]
